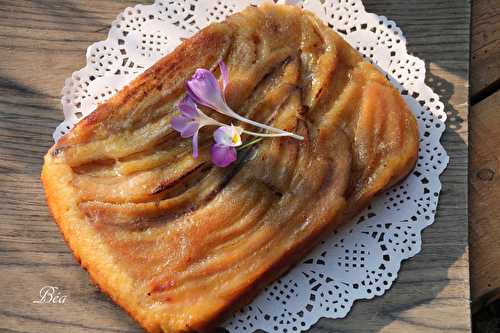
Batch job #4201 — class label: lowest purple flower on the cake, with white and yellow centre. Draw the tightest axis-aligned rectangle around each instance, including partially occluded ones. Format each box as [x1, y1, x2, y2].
[211, 125, 243, 168]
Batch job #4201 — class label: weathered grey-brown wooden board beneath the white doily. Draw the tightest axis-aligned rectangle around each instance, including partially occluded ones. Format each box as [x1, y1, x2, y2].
[0, 0, 468, 333]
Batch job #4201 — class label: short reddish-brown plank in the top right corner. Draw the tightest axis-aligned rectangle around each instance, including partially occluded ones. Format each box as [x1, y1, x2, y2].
[470, 0, 500, 96]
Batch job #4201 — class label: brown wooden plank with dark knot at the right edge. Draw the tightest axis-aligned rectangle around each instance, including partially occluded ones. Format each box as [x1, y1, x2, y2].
[469, 91, 500, 308]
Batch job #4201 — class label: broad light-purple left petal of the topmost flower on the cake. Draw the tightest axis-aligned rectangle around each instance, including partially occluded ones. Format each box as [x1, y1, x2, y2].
[187, 68, 226, 110]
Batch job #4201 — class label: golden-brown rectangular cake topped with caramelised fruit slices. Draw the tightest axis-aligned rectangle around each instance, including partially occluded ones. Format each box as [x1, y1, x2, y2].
[42, 5, 418, 332]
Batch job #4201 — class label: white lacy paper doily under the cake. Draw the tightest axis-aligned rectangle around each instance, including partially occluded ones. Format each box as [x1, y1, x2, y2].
[54, 0, 448, 333]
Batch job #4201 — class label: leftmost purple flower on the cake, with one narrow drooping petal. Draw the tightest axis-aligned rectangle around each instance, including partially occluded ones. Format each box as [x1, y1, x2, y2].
[170, 95, 220, 158]
